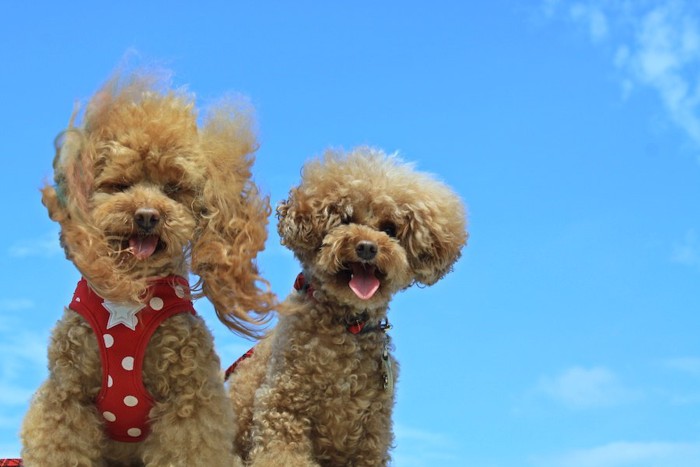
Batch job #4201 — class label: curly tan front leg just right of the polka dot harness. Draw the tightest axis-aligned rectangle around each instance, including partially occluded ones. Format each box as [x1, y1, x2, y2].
[143, 315, 242, 467]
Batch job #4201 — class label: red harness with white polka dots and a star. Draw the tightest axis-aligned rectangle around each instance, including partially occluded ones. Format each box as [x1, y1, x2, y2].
[70, 276, 195, 442]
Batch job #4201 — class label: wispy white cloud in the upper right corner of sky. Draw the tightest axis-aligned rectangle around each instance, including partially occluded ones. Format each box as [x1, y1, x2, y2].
[541, 0, 700, 152]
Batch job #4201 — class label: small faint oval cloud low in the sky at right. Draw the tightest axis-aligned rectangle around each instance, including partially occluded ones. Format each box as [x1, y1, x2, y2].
[537, 367, 636, 409]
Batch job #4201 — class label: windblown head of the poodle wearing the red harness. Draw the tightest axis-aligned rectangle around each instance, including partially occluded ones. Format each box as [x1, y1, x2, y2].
[42, 74, 274, 334]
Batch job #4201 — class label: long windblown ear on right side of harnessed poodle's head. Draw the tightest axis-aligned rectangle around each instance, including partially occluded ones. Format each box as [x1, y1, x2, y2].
[192, 105, 277, 337]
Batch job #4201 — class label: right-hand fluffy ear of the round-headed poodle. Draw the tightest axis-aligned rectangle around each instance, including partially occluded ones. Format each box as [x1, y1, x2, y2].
[404, 180, 468, 285]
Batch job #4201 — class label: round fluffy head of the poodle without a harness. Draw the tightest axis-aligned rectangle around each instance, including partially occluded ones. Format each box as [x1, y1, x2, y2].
[277, 147, 467, 309]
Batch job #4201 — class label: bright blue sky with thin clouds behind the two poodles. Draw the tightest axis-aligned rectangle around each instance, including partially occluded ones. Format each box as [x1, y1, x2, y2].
[0, 0, 700, 467]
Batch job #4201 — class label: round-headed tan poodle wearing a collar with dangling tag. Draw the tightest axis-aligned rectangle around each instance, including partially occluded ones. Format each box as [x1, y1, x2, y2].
[230, 148, 467, 467]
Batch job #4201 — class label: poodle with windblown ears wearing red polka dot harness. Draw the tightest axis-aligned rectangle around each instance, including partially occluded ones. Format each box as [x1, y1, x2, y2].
[21, 73, 274, 467]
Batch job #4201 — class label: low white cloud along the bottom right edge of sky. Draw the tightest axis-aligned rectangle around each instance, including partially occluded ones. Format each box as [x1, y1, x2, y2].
[534, 441, 700, 467]
